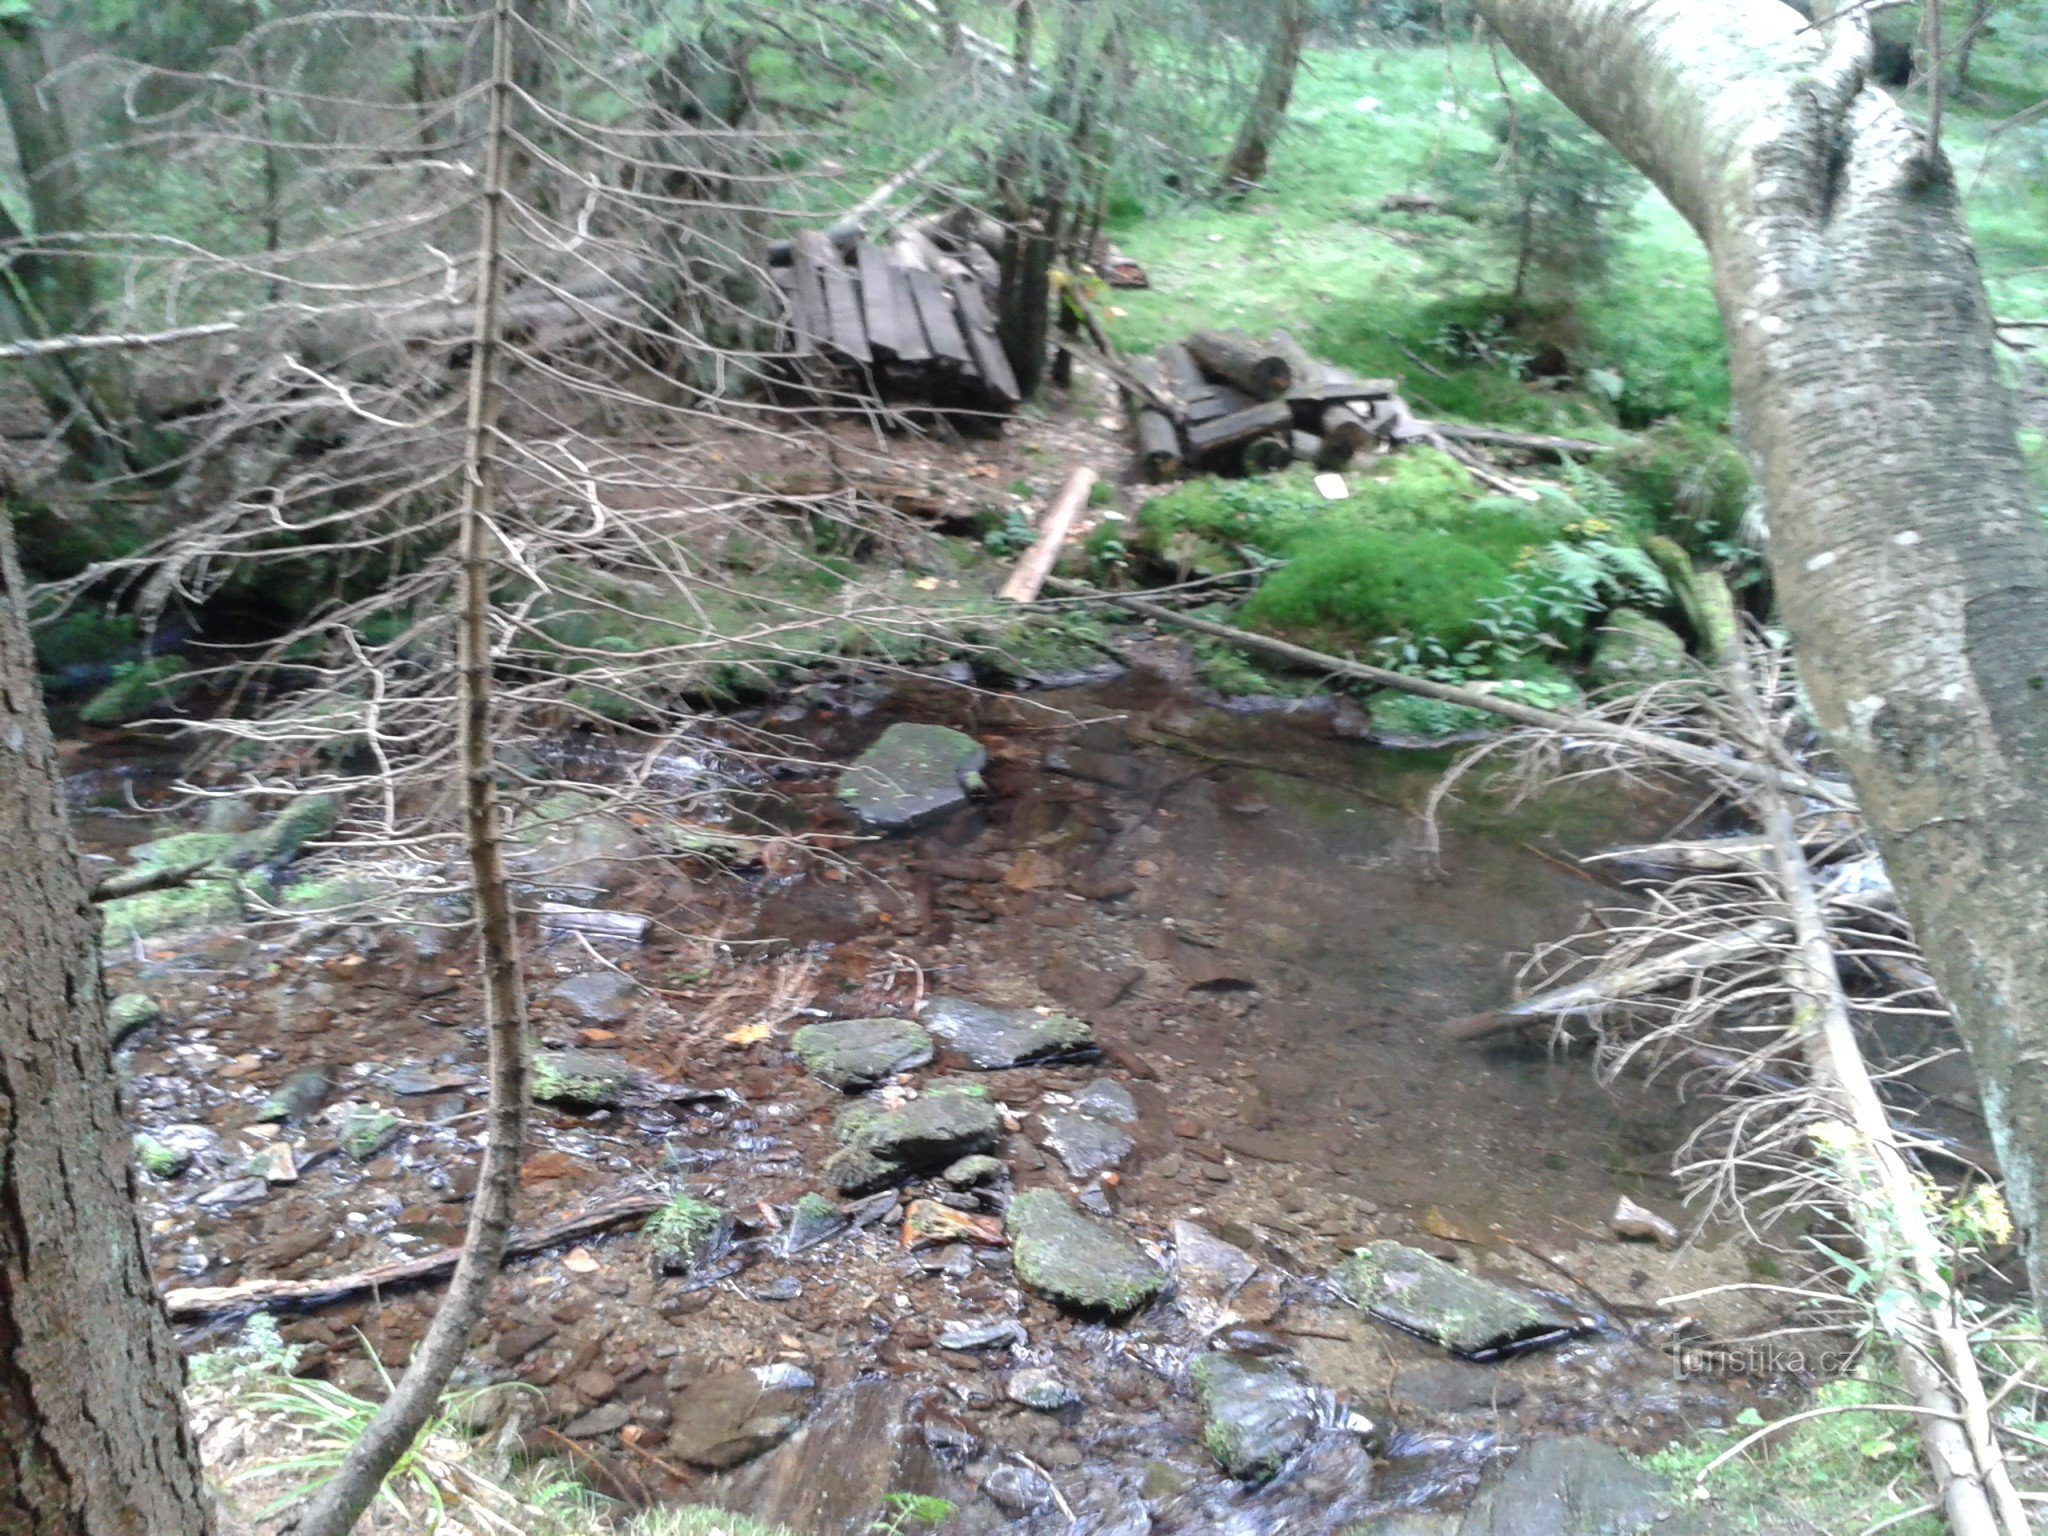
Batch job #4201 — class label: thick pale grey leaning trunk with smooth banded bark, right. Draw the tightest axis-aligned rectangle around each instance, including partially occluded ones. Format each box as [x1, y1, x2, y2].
[1479, 0, 2048, 1313]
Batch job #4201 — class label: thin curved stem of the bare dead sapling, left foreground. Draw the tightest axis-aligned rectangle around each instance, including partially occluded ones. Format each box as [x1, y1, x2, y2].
[297, 0, 526, 1536]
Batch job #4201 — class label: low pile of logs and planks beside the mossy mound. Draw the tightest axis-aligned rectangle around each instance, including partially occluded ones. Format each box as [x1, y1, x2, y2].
[1133, 330, 1405, 481]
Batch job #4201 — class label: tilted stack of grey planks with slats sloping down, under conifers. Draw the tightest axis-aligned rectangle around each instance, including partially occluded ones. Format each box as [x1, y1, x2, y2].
[770, 221, 1022, 412]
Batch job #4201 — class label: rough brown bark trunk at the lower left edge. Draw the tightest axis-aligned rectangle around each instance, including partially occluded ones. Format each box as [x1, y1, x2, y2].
[0, 501, 213, 1536]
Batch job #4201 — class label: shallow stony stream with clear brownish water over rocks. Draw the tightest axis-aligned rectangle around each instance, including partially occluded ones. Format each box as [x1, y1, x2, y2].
[88, 649, 1776, 1532]
